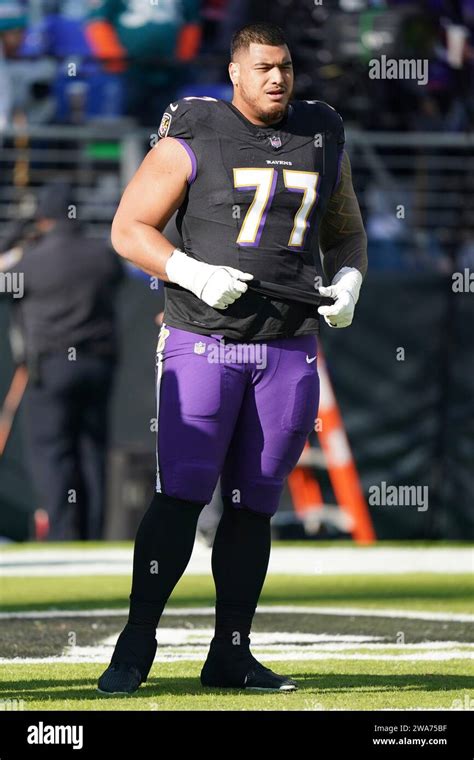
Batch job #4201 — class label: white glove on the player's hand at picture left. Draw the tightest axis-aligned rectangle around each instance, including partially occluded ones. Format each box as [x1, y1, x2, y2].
[165, 248, 253, 309]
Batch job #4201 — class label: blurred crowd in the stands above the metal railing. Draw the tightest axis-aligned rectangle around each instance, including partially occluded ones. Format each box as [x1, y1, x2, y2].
[0, 0, 474, 131]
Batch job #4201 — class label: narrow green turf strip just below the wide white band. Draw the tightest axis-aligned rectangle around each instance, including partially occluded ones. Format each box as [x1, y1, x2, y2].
[0, 573, 474, 612]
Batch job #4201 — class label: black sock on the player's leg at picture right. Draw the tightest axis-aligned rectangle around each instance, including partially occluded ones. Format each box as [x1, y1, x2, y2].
[212, 503, 271, 653]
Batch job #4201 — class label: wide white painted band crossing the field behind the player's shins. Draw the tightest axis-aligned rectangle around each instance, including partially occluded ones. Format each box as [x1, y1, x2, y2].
[0, 542, 474, 577]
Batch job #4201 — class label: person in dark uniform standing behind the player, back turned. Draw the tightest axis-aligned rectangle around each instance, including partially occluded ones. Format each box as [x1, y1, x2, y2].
[0, 183, 122, 540]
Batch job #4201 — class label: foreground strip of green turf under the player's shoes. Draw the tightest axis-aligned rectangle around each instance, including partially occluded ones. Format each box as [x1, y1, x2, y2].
[0, 660, 473, 710]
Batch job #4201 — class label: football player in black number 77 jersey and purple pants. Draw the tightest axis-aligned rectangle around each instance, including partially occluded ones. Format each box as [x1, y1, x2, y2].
[99, 24, 367, 694]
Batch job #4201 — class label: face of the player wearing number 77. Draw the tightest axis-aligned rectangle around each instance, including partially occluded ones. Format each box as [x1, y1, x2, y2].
[229, 42, 293, 124]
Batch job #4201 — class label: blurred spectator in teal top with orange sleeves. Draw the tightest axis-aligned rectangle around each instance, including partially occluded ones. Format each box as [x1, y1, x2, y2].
[86, 0, 201, 126]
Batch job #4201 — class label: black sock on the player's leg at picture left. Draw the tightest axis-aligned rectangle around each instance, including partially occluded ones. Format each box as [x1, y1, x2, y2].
[112, 493, 204, 678]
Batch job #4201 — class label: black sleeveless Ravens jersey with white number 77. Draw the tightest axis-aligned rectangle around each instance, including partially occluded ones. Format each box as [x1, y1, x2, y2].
[159, 98, 344, 341]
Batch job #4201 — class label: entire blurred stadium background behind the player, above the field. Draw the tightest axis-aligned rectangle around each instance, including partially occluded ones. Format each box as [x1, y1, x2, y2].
[0, 0, 474, 543]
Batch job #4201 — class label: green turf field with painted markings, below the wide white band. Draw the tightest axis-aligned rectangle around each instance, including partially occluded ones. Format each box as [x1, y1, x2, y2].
[0, 544, 474, 711]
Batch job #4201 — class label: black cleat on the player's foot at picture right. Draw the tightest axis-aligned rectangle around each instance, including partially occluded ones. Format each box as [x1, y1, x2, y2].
[201, 647, 298, 691]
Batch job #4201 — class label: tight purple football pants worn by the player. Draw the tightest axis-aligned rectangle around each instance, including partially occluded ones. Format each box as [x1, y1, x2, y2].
[156, 325, 319, 515]
